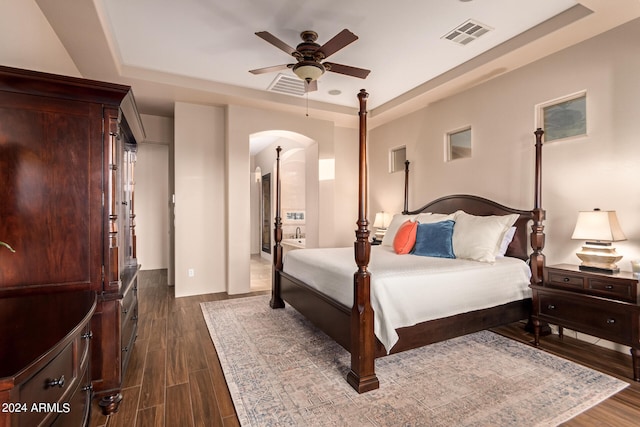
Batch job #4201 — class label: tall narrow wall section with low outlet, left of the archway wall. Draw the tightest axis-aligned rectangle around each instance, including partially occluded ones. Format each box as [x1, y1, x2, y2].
[175, 102, 226, 297]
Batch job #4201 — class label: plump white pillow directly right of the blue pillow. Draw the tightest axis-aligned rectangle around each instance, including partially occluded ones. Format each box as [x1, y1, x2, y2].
[453, 211, 519, 263]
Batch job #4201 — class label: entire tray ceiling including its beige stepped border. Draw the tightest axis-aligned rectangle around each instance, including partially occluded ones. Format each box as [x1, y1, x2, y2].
[36, 0, 640, 127]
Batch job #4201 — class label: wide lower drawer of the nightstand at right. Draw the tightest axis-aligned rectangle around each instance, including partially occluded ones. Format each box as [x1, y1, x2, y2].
[538, 293, 633, 345]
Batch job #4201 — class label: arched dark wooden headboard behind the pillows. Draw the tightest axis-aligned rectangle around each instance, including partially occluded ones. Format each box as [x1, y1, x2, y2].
[405, 194, 534, 261]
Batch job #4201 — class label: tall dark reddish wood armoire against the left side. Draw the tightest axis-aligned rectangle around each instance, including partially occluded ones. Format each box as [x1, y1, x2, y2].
[0, 67, 144, 413]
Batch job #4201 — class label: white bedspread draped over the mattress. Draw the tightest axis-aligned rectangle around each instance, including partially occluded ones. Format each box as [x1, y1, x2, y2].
[284, 246, 531, 352]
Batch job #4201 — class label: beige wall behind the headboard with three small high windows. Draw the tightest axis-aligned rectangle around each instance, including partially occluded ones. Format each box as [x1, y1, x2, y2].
[370, 20, 640, 270]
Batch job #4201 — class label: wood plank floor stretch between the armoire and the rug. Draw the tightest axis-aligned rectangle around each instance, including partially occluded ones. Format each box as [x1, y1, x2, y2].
[89, 270, 268, 427]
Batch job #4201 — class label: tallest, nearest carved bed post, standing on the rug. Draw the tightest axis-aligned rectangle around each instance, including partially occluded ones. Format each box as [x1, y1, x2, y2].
[347, 89, 380, 393]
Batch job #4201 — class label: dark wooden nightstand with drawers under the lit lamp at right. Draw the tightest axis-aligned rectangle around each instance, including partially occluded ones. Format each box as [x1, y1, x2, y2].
[531, 264, 640, 381]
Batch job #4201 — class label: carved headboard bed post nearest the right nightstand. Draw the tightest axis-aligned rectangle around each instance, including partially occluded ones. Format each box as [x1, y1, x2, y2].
[529, 128, 545, 285]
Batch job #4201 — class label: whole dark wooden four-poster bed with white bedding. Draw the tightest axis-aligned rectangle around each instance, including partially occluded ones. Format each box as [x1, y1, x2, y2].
[270, 90, 545, 393]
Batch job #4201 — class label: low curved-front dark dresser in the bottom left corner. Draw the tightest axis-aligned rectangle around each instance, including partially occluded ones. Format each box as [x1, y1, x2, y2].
[0, 291, 96, 427]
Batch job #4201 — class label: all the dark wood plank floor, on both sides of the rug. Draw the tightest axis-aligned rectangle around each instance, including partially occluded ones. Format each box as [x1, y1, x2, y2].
[90, 270, 640, 427]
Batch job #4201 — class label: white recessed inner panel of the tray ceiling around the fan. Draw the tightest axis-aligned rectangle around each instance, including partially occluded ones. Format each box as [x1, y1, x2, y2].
[102, 0, 576, 108]
